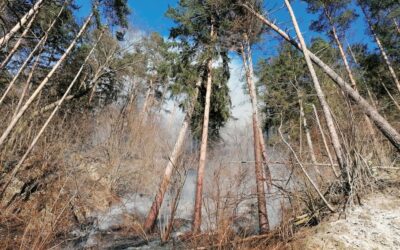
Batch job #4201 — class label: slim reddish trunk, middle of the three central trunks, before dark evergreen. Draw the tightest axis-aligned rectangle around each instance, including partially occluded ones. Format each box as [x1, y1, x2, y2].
[192, 24, 215, 234]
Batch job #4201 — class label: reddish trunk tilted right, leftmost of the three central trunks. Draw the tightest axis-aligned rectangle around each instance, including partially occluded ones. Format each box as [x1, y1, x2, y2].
[143, 80, 201, 232]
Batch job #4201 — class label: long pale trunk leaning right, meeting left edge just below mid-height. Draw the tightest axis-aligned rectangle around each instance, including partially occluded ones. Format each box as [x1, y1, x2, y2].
[0, 13, 93, 149]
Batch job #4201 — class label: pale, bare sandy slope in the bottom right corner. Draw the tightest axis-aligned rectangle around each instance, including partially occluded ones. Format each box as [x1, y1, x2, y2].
[290, 167, 400, 250]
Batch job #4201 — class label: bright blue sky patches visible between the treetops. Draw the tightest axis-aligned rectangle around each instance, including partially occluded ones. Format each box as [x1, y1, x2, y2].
[76, 0, 375, 60]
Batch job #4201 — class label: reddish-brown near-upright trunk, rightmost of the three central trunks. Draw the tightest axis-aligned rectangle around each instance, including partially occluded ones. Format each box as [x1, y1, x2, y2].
[240, 41, 269, 234]
